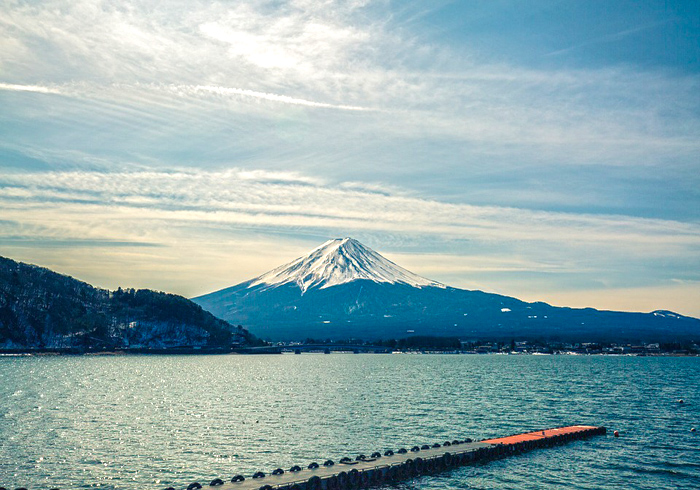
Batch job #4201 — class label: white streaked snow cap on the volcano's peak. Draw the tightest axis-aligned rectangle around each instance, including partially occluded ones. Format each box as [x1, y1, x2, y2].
[249, 238, 445, 293]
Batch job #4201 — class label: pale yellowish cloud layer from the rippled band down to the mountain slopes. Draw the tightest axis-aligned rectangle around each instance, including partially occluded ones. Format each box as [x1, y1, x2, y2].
[0, 169, 700, 311]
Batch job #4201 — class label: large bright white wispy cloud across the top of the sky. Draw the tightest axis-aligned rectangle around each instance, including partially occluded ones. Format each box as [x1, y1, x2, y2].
[0, 1, 700, 165]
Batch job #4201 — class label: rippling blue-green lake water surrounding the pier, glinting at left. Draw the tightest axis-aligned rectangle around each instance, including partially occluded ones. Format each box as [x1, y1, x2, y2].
[0, 354, 700, 490]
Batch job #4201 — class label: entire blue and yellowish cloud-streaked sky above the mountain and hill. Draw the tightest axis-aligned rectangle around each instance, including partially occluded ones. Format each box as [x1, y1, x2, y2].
[0, 0, 700, 317]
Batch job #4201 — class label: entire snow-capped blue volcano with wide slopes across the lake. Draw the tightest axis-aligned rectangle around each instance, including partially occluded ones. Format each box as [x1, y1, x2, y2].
[193, 238, 700, 341]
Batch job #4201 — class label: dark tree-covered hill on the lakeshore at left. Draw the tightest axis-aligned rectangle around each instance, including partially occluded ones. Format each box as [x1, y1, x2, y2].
[0, 257, 259, 350]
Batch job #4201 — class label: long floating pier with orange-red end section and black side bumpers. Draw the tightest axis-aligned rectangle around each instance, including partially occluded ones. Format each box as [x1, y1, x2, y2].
[176, 425, 606, 490]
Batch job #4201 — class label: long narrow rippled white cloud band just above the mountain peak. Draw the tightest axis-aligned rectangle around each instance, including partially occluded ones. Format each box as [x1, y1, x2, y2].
[0, 169, 700, 257]
